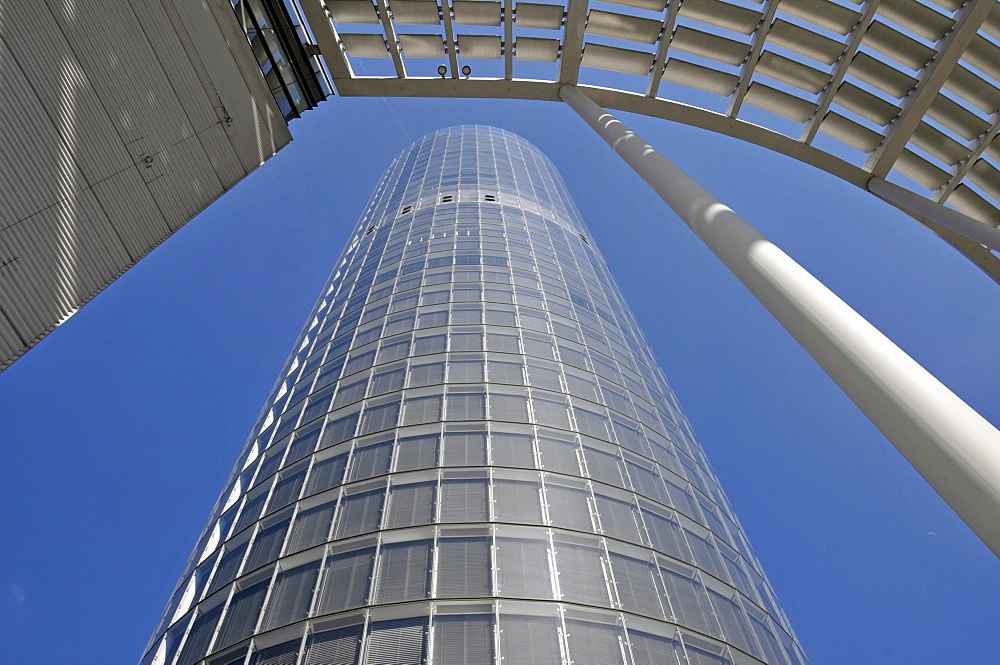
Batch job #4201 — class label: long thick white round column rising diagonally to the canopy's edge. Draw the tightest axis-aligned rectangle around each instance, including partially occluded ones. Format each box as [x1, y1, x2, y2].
[559, 85, 1000, 556]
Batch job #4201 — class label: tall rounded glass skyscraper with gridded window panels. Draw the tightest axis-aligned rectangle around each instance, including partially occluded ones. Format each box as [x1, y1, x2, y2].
[142, 126, 805, 665]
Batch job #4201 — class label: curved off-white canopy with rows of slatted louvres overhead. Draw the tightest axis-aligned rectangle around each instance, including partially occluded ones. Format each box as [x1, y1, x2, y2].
[299, 0, 1000, 281]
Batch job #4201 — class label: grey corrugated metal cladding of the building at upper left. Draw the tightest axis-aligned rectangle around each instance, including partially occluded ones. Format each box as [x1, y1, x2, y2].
[0, 0, 291, 370]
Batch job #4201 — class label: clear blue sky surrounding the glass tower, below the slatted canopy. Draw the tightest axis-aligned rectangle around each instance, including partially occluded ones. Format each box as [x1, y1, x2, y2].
[0, 99, 1000, 665]
